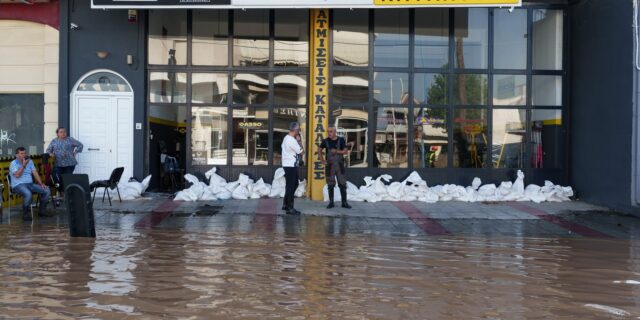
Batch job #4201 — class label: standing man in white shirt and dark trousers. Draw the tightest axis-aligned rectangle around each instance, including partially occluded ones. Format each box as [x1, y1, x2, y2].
[282, 122, 304, 215]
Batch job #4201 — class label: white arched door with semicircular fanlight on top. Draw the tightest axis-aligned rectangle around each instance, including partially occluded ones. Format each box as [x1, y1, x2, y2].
[71, 71, 133, 181]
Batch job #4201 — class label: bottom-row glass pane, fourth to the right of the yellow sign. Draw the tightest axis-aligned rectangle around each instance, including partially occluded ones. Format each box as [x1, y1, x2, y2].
[453, 109, 487, 168]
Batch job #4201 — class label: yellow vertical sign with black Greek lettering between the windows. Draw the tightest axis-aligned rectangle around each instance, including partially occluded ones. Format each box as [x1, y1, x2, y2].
[307, 9, 329, 200]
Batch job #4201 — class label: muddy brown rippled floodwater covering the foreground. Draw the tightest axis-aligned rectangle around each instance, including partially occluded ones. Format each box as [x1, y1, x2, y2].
[0, 219, 640, 319]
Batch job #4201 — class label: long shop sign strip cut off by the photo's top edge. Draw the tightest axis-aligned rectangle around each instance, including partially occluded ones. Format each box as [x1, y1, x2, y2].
[91, 0, 522, 9]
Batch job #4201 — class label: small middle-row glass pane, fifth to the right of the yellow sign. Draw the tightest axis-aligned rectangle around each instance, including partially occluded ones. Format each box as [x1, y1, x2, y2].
[493, 74, 527, 106]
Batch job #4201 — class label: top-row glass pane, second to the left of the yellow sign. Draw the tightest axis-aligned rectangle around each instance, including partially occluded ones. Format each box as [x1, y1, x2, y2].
[233, 10, 269, 66]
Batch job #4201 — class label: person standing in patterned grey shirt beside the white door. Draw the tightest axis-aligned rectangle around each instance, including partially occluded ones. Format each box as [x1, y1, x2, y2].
[47, 127, 83, 196]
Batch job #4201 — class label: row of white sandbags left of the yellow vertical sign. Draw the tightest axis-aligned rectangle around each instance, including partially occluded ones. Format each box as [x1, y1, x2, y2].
[174, 167, 307, 201]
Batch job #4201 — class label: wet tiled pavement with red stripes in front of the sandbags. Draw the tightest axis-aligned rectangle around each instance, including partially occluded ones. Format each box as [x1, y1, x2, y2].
[2, 194, 640, 239]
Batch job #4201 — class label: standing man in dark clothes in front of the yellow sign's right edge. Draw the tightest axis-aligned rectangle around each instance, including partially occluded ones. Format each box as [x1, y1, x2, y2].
[318, 127, 351, 209]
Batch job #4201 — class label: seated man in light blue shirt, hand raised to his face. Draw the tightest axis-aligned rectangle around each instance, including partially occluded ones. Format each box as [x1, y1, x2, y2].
[9, 147, 51, 221]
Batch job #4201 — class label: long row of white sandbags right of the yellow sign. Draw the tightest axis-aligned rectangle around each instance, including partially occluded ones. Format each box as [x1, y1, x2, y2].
[323, 170, 573, 203]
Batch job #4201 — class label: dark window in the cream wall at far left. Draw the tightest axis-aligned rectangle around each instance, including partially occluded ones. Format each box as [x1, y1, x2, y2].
[0, 93, 43, 157]
